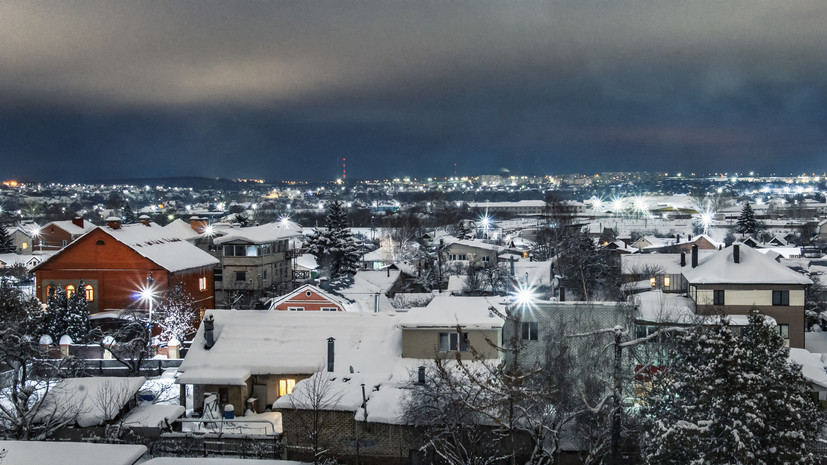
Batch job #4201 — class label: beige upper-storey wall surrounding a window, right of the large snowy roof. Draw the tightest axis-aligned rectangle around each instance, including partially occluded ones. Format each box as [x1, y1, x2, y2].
[402, 328, 500, 360]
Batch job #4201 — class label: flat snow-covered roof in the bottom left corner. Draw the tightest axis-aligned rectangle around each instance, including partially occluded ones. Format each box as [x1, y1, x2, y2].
[0, 441, 146, 465]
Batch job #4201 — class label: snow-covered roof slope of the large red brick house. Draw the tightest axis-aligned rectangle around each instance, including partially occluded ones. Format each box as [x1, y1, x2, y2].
[100, 223, 220, 271]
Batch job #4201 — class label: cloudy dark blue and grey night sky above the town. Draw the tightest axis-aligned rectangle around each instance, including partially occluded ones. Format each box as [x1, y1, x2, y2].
[0, 0, 827, 181]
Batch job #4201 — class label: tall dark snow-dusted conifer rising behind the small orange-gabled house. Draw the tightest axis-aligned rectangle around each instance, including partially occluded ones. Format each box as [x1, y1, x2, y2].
[307, 200, 359, 288]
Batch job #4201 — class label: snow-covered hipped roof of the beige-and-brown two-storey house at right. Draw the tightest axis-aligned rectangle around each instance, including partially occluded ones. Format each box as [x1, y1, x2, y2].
[683, 244, 813, 285]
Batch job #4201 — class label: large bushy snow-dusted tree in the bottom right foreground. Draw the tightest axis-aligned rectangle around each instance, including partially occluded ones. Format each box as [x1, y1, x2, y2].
[641, 312, 821, 464]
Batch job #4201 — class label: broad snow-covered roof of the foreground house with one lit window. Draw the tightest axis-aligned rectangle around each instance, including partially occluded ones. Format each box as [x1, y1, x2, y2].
[178, 310, 402, 385]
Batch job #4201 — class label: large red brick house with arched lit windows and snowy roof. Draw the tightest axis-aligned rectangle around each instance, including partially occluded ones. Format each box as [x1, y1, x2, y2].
[33, 221, 219, 313]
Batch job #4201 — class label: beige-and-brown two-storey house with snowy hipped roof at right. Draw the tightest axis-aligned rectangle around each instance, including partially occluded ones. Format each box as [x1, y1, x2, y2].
[683, 244, 813, 348]
